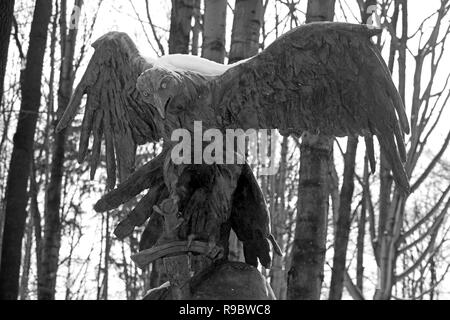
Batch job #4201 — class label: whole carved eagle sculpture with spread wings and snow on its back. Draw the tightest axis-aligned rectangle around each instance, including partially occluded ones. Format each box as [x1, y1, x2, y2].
[58, 22, 410, 294]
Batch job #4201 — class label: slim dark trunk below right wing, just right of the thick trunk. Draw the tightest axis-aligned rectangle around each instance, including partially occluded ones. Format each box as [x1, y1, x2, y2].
[329, 137, 358, 300]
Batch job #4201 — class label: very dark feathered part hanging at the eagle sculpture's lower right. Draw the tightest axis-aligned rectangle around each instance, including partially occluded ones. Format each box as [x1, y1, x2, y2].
[231, 164, 282, 268]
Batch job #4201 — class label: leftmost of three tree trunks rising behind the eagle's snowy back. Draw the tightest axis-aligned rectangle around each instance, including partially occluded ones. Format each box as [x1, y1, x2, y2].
[169, 0, 195, 54]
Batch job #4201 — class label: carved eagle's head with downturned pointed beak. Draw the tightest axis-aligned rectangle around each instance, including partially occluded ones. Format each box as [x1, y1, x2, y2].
[136, 66, 181, 119]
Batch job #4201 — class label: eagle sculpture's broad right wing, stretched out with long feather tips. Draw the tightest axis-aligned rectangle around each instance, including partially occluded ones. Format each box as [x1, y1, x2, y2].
[214, 23, 409, 192]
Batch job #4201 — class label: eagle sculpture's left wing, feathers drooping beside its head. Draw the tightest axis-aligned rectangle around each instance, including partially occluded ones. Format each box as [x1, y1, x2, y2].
[57, 32, 159, 189]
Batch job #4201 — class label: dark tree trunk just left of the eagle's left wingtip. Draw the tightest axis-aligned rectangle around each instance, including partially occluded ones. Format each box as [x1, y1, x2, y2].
[38, 0, 83, 300]
